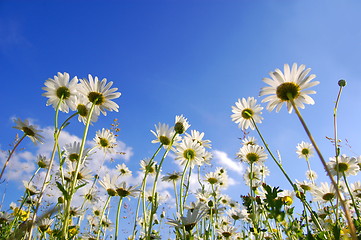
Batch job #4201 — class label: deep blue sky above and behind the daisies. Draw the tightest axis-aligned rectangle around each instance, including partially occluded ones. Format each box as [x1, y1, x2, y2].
[0, 0, 361, 232]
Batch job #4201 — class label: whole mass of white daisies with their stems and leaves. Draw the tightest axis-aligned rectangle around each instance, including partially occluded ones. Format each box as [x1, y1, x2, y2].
[0, 64, 361, 240]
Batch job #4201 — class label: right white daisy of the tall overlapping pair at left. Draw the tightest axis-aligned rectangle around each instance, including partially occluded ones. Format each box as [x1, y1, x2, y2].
[78, 74, 121, 116]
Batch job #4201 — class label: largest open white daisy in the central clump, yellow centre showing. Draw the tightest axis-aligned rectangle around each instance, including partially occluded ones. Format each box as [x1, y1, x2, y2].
[175, 137, 205, 169]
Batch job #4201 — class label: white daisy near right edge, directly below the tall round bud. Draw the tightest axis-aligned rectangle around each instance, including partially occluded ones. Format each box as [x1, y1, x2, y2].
[327, 154, 360, 176]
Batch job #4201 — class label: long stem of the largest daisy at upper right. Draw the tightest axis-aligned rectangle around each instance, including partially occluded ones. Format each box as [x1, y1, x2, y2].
[287, 93, 357, 240]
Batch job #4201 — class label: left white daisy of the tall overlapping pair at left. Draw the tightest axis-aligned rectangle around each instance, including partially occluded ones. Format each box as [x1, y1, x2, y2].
[42, 72, 78, 113]
